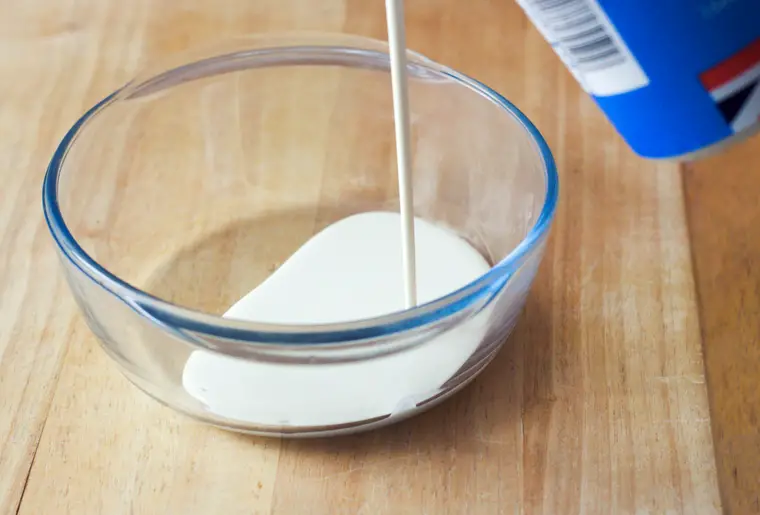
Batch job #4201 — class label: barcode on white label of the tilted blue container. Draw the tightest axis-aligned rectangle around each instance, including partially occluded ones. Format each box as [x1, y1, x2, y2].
[518, 0, 649, 96]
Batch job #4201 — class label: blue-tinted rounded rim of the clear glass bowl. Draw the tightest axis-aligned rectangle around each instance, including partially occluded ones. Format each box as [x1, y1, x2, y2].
[42, 33, 559, 350]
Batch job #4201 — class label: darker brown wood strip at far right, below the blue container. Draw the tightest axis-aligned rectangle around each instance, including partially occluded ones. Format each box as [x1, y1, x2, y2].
[684, 136, 760, 514]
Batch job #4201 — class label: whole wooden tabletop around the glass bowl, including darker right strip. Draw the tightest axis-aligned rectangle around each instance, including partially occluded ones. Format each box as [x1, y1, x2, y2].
[0, 0, 760, 515]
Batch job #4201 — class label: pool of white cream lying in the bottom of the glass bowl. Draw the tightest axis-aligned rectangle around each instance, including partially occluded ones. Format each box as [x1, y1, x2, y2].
[182, 212, 490, 426]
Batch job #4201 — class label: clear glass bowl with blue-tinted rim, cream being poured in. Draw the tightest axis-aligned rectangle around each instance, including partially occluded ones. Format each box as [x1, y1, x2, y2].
[43, 34, 557, 436]
